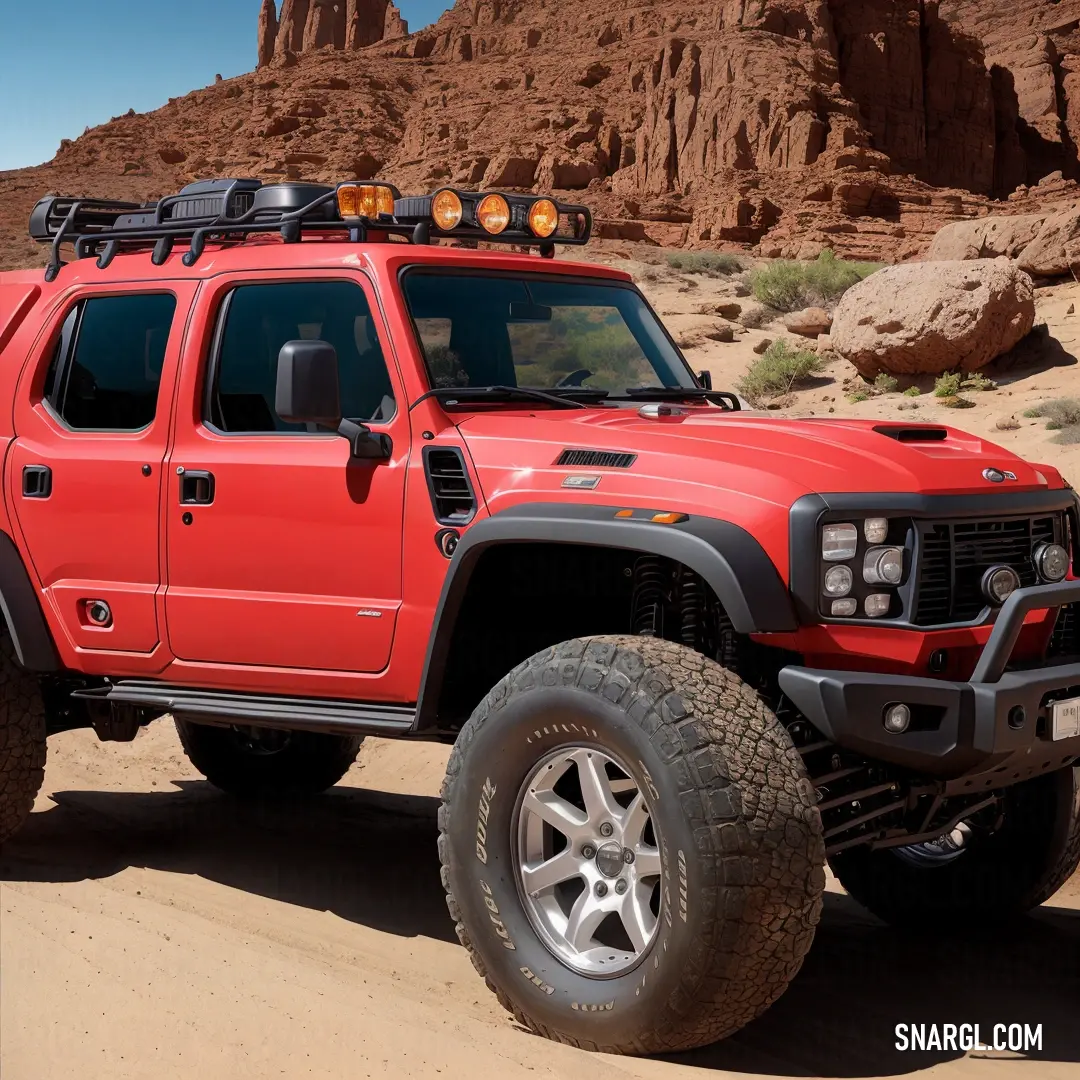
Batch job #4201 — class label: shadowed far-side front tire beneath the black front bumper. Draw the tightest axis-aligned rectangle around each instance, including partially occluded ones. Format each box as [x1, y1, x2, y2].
[831, 768, 1080, 932]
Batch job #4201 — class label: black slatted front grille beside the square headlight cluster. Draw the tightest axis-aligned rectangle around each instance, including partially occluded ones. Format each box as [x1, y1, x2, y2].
[913, 514, 1062, 626]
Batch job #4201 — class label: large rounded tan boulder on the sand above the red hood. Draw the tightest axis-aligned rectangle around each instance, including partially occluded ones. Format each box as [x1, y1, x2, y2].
[831, 258, 1035, 379]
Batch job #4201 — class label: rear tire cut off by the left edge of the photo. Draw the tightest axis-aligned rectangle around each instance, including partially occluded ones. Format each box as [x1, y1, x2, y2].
[0, 633, 45, 843]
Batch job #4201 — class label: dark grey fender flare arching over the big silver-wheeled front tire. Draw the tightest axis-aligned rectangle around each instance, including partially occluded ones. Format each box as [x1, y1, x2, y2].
[416, 502, 798, 730]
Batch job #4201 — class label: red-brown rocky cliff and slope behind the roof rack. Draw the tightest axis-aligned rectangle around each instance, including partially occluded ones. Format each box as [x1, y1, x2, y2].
[0, 0, 1080, 272]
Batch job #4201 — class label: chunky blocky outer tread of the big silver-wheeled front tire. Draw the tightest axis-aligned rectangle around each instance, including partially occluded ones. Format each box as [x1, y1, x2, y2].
[438, 636, 825, 1054]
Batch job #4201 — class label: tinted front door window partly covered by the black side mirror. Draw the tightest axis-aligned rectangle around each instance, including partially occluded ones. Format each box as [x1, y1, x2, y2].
[206, 281, 396, 433]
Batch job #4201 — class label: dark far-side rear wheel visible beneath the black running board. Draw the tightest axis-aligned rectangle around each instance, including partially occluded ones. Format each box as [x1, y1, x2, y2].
[176, 719, 364, 798]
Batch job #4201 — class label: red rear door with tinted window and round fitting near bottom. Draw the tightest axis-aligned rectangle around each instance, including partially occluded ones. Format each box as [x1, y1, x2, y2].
[5, 282, 195, 656]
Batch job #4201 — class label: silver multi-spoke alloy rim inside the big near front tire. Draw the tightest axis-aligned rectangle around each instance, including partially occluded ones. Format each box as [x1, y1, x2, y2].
[515, 746, 661, 977]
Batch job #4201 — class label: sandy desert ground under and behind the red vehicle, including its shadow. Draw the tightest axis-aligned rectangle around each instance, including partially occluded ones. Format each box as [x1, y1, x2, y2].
[0, 249, 1080, 1080]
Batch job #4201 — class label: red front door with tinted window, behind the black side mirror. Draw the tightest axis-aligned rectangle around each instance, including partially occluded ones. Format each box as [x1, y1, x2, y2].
[165, 273, 408, 677]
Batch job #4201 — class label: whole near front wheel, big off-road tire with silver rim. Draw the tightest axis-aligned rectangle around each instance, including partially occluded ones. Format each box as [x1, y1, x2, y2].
[438, 637, 825, 1053]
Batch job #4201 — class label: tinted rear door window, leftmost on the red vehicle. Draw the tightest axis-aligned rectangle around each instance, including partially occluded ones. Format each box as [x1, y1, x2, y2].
[45, 293, 176, 431]
